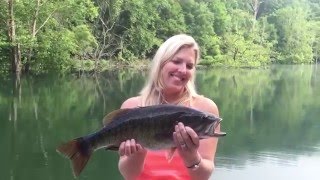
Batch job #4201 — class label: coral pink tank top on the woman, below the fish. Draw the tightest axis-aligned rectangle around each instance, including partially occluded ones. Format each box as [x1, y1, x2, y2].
[137, 151, 191, 180]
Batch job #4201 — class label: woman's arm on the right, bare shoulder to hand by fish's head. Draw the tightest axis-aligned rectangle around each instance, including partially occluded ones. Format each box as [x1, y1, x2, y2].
[173, 97, 220, 180]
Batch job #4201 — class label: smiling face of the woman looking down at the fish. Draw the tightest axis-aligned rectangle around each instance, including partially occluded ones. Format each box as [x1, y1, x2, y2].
[161, 47, 196, 93]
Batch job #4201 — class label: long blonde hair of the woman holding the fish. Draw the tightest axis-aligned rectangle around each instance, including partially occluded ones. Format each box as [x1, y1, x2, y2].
[140, 34, 200, 106]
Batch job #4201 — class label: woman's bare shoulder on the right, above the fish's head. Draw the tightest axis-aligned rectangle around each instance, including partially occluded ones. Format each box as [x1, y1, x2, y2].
[193, 96, 219, 116]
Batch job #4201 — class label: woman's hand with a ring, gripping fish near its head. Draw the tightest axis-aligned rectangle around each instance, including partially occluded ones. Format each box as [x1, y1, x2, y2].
[173, 122, 201, 167]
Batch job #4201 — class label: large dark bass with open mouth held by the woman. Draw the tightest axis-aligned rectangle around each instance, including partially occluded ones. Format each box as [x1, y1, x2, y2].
[56, 104, 226, 177]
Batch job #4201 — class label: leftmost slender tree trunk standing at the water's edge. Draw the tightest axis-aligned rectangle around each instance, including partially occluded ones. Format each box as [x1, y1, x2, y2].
[8, 0, 21, 74]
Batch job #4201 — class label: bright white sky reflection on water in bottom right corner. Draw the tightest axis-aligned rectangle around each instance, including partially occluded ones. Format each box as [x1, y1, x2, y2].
[211, 153, 320, 180]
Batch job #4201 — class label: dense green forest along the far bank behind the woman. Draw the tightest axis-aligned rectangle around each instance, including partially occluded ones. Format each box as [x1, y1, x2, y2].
[0, 0, 320, 73]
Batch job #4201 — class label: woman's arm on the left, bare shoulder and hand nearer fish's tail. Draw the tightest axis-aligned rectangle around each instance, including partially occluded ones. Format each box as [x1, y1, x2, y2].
[118, 97, 147, 180]
